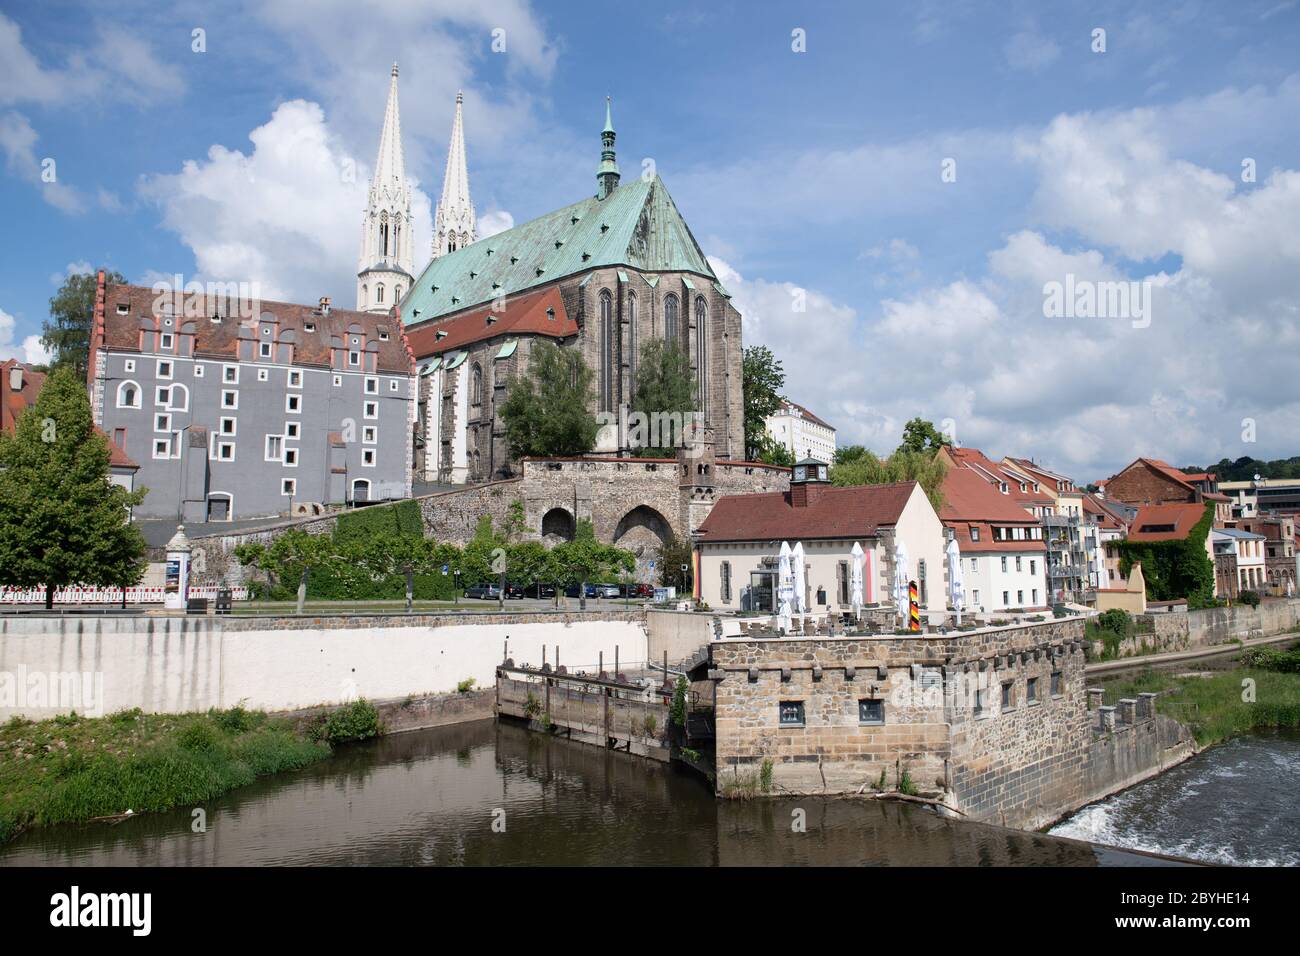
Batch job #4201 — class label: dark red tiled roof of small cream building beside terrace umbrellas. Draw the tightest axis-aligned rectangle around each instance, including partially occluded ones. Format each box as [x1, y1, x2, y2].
[699, 481, 918, 544]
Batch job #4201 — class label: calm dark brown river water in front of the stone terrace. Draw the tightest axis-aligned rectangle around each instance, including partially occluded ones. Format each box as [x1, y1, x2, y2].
[0, 721, 1185, 866]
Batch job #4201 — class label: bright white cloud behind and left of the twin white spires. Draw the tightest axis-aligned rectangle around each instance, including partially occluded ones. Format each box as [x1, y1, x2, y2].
[140, 100, 432, 304]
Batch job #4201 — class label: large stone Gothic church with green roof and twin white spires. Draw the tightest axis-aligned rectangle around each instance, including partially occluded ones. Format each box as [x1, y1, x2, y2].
[358, 66, 745, 484]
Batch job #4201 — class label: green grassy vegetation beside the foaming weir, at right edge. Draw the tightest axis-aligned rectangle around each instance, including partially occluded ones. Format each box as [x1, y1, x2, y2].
[1102, 645, 1300, 747]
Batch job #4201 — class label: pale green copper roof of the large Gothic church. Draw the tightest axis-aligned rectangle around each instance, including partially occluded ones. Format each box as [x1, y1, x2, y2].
[402, 176, 718, 326]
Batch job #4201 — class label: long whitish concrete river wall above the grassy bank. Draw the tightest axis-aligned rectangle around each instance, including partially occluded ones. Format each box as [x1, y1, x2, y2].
[0, 611, 647, 719]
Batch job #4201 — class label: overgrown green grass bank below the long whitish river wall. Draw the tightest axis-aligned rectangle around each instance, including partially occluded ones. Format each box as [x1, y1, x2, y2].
[0, 708, 340, 844]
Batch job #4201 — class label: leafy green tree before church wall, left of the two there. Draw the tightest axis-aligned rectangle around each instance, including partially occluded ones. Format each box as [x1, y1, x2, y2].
[501, 342, 599, 458]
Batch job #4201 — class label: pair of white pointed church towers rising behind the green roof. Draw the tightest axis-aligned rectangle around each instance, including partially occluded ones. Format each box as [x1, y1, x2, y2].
[356, 64, 478, 312]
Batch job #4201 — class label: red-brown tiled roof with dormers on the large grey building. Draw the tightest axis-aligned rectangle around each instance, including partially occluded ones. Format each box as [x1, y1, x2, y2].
[102, 284, 412, 375]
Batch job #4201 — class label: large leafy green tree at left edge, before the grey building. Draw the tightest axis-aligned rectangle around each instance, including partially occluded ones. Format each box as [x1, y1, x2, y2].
[0, 367, 146, 607]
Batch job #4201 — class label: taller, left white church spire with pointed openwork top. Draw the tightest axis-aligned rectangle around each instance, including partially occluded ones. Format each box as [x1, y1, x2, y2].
[356, 64, 413, 312]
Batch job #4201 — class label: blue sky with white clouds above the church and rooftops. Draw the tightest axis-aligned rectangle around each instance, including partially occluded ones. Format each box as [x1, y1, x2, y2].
[0, 0, 1300, 481]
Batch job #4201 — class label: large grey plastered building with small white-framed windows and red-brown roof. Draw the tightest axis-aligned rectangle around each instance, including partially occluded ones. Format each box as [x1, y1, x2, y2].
[90, 273, 416, 522]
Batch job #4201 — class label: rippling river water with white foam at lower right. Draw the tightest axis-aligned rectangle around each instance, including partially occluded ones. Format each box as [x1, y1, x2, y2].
[1052, 731, 1300, 866]
